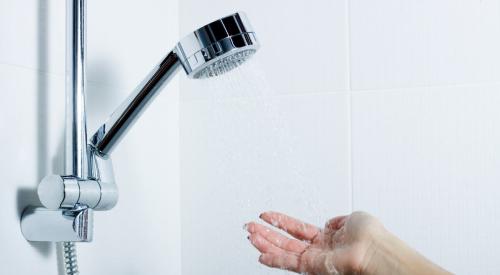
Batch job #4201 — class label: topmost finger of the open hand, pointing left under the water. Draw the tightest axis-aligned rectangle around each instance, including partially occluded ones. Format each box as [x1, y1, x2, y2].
[260, 212, 319, 241]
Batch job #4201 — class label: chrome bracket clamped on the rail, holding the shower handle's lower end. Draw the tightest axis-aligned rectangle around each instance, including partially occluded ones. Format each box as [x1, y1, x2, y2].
[21, 149, 118, 242]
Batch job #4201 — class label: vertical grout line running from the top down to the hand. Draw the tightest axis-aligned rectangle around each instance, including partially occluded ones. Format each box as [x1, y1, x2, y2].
[345, 0, 354, 212]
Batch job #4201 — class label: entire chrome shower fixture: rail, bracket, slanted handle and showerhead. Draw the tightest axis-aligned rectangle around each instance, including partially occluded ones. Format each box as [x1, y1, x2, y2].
[21, 0, 259, 251]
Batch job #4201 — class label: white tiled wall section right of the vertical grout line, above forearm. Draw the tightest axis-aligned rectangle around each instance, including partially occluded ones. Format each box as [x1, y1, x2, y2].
[350, 0, 500, 274]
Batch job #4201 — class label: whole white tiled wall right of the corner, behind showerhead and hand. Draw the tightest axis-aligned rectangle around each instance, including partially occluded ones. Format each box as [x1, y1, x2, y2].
[180, 0, 500, 275]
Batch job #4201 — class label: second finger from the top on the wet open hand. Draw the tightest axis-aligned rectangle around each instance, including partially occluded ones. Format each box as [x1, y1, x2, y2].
[247, 222, 309, 253]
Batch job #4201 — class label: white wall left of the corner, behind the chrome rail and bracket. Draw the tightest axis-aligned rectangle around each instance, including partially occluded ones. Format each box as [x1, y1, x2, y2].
[0, 0, 181, 275]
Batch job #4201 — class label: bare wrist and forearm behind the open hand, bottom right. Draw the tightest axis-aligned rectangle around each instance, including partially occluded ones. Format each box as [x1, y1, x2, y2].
[363, 232, 451, 275]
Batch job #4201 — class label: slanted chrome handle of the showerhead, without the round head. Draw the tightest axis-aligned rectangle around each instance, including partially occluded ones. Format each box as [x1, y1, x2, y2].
[90, 51, 181, 158]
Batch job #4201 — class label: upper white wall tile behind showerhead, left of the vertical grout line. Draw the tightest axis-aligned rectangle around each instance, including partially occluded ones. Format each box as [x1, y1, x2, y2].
[180, 0, 347, 93]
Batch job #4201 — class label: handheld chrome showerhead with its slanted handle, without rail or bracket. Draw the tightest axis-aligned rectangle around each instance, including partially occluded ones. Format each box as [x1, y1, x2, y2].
[92, 13, 259, 156]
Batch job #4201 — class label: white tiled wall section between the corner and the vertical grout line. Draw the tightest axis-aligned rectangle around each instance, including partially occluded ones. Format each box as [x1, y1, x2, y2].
[180, 0, 351, 275]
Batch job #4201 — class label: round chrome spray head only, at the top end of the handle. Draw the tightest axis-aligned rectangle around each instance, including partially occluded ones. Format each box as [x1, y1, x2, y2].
[175, 13, 259, 79]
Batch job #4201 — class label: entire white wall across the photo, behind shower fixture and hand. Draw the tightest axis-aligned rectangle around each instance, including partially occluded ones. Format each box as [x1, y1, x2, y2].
[0, 0, 500, 275]
